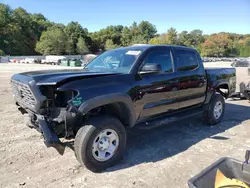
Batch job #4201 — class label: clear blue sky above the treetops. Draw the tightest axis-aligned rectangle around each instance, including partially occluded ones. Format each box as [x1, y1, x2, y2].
[0, 0, 250, 34]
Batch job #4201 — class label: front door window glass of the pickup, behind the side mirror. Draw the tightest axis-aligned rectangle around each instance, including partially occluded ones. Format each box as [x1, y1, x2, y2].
[144, 50, 173, 73]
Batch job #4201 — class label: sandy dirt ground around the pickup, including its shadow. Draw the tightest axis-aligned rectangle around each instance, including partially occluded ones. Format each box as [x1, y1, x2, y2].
[0, 64, 250, 188]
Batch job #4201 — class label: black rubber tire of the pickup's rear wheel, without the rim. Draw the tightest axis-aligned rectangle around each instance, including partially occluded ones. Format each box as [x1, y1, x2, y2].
[204, 93, 225, 125]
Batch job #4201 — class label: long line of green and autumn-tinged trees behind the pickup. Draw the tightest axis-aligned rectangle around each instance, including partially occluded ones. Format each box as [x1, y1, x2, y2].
[0, 3, 250, 57]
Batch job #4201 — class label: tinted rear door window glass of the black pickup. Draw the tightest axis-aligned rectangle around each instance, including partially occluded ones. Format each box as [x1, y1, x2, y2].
[175, 50, 199, 71]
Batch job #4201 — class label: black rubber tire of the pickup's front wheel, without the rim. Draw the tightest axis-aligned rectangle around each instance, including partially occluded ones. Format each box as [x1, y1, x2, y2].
[74, 116, 127, 172]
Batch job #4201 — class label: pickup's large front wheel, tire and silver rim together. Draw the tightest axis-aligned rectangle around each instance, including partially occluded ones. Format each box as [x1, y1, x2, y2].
[74, 116, 127, 172]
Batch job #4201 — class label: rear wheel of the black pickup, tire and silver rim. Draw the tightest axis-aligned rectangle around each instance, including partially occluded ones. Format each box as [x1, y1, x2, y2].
[204, 93, 225, 125]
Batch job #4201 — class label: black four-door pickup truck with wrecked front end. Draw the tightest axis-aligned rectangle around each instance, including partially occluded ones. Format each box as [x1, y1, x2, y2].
[11, 45, 236, 172]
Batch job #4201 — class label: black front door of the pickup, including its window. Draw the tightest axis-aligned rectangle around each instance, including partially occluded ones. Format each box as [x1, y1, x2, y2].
[136, 47, 179, 120]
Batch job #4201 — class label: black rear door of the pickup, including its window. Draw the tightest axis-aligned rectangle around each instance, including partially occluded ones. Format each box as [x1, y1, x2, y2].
[174, 48, 207, 109]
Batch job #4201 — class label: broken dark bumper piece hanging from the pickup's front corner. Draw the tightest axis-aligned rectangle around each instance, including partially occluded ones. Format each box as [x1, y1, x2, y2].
[37, 115, 65, 155]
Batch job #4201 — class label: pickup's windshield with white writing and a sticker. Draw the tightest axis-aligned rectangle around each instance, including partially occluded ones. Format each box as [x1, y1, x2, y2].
[84, 49, 142, 73]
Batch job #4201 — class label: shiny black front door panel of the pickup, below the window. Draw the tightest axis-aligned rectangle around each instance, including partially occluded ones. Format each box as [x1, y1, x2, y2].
[139, 73, 179, 118]
